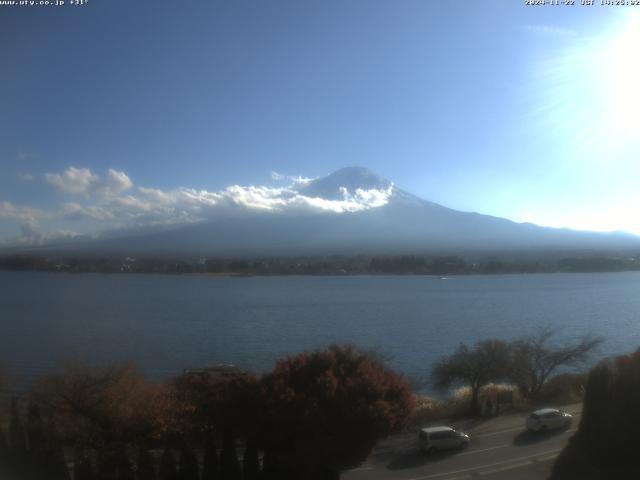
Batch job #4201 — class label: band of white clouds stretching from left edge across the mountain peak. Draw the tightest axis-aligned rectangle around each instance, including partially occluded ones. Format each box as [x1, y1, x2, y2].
[0, 166, 393, 243]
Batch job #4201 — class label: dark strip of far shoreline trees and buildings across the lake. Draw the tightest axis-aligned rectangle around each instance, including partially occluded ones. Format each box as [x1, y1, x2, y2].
[0, 254, 640, 276]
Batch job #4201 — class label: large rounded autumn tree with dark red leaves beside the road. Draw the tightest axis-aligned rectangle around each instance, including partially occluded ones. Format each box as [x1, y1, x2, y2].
[261, 345, 415, 480]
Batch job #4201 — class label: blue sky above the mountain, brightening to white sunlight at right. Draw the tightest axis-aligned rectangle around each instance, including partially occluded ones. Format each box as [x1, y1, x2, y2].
[0, 0, 640, 243]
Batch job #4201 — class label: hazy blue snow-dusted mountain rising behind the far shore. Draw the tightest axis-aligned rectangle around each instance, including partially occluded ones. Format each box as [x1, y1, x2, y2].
[20, 167, 640, 256]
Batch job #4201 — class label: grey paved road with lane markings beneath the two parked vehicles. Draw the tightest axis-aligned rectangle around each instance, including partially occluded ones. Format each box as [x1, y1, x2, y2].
[342, 405, 581, 480]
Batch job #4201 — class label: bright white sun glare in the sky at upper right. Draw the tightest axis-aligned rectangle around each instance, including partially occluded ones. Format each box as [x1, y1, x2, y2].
[531, 12, 640, 169]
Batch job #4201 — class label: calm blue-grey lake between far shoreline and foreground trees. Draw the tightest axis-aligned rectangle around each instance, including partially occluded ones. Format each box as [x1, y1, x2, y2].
[0, 272, 640, 390]
